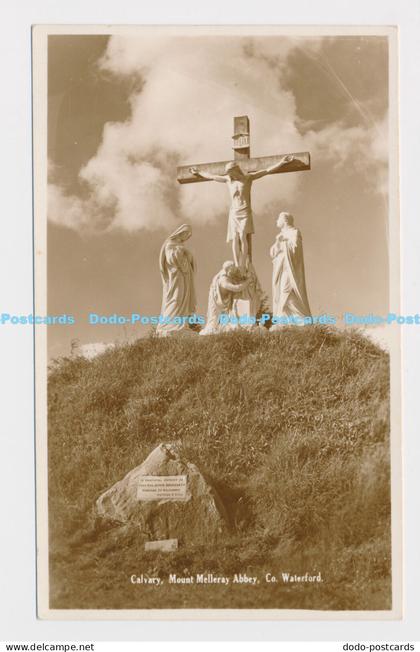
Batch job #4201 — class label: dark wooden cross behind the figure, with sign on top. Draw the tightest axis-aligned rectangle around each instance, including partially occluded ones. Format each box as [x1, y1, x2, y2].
[177, 115, 311, 183]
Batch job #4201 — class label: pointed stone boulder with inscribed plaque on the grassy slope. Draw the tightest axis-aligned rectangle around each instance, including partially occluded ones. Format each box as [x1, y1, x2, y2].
[96, 444, 228, 546]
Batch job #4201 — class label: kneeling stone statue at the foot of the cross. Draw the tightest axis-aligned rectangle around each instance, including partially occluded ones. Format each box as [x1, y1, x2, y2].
[200, 260, 251, 335]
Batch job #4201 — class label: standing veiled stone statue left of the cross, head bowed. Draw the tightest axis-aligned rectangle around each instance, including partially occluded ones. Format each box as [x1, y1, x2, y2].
[156, 224, 196, 337]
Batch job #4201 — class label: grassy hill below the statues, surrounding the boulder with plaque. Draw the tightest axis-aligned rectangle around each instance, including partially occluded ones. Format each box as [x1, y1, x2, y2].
[48, 327, 391, 610]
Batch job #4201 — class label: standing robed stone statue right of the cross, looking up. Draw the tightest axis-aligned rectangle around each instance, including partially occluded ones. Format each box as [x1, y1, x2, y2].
[270, 213, 311, 329]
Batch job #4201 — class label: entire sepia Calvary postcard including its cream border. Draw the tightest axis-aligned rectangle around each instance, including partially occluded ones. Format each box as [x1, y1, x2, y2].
[32, 25, 400, 620]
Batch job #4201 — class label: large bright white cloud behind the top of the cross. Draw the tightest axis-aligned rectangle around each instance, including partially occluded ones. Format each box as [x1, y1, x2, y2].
[49, 36, 390, 231]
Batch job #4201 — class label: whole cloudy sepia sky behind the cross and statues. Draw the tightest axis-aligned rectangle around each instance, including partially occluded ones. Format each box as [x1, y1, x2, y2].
[44, 32, 389, 357]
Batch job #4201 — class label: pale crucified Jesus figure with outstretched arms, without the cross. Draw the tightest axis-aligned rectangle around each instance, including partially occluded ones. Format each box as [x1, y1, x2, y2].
[190, 155, 294, 271]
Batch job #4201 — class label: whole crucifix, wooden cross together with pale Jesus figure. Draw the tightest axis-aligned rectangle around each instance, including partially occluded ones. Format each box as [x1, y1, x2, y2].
[177, 115, 311, 270]
